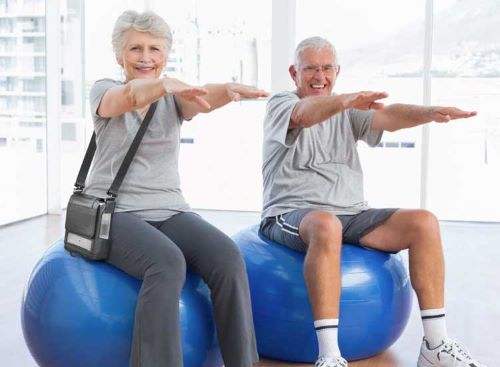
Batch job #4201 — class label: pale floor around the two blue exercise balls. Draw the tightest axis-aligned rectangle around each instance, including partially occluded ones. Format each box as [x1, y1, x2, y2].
[0, 211, 500, 367]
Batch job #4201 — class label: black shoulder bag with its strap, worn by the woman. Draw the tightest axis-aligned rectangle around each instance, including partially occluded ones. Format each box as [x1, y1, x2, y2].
[64, 102, 157, 260]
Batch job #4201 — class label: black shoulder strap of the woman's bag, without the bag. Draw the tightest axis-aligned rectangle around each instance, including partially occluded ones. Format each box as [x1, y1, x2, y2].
[74, 102, 158, 197]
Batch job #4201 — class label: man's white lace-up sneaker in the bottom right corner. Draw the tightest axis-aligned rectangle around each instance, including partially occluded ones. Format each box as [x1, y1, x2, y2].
[417, 338, 487, 367]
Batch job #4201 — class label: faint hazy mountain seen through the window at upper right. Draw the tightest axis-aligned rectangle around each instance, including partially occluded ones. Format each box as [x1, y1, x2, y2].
[342, 0, 500, 78]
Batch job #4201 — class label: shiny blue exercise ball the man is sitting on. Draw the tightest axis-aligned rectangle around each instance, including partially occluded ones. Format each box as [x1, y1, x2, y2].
[233, 226, 412, 362]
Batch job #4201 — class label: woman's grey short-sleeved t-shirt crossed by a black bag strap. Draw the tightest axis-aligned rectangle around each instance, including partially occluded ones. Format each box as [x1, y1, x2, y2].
[85, 79, 190, 221]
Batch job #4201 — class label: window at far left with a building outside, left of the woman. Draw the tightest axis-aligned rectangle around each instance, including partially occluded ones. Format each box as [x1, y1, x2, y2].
[0, 0, 84, 224]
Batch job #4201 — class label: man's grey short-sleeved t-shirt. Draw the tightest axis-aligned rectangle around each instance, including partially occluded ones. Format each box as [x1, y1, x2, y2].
[262, 92, 382, 218]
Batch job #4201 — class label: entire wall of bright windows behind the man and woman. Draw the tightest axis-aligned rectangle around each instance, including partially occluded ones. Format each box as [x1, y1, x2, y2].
[0, 0, 500, 225]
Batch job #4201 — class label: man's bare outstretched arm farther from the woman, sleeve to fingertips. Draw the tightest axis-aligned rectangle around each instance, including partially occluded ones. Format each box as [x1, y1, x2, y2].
[371, 104, 477, 131]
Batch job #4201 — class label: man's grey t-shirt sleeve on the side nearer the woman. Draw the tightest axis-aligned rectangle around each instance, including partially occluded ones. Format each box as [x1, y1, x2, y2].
[264, 92, 302, 147]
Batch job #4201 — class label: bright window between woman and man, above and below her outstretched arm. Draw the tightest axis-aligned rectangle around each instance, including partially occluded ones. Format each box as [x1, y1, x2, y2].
[154, 0, 271, 211]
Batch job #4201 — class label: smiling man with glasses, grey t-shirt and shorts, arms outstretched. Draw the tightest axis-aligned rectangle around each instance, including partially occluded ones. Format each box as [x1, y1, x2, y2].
[260, 37, 484, 367]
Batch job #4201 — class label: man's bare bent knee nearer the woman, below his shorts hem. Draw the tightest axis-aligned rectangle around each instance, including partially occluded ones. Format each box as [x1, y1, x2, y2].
[299, 210, 342, 248]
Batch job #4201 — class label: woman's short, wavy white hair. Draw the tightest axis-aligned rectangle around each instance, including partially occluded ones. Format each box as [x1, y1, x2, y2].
[111, 10, 172, 57]
